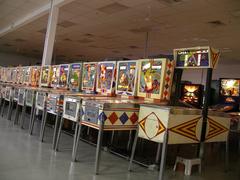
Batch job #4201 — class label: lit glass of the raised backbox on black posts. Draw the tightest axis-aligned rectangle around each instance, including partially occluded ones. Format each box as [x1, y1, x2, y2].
[176, 48, 210, 67]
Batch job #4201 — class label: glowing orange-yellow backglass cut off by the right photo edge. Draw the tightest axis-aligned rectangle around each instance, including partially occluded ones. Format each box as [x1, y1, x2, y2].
[220, 79, 240, 97]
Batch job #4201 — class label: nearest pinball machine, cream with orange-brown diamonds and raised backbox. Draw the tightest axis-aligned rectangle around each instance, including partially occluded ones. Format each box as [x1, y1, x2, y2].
[129, 46, 232, 180]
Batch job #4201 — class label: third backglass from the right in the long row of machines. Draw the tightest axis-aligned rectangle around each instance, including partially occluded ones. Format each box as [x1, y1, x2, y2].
[98, 63, 115, 91]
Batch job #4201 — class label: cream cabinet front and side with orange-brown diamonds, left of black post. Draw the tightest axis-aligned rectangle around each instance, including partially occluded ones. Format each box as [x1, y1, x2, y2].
[138, 105, 202, 144]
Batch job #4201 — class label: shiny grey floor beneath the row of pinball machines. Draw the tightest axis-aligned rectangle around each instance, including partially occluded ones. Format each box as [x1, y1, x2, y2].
[0, 114, 240, 180]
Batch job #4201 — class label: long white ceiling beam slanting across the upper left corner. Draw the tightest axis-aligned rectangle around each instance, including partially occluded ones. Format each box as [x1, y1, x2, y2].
[0, 0, 73, 37]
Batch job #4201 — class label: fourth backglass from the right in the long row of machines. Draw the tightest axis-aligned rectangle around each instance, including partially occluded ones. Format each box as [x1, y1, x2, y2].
[82, 63, 98, 93]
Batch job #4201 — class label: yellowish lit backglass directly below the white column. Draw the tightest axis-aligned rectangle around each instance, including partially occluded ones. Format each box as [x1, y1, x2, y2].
[40, 65, 52, 87]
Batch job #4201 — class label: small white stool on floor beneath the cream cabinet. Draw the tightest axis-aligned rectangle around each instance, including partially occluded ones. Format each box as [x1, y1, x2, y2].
[173, 156, 202, 176]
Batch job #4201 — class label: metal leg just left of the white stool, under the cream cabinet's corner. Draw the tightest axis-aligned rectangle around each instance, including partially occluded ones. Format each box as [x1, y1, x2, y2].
[159, 131, 168, 180]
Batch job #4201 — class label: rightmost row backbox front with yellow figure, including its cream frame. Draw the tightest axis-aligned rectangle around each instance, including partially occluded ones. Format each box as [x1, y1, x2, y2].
[138, 59, 167, 99]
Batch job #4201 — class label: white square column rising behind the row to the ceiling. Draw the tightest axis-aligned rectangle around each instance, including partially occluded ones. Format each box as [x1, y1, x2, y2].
[42, 0, 59, 65]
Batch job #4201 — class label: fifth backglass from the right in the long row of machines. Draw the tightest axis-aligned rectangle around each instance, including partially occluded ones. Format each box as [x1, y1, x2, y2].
[69, 63, 82, 92]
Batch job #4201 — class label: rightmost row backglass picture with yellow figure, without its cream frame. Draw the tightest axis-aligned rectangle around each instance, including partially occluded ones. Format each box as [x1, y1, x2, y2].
[139, 60, 162, 94]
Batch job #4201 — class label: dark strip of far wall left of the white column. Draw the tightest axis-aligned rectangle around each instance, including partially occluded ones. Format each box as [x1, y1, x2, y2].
[0, 52, 42, 66]
